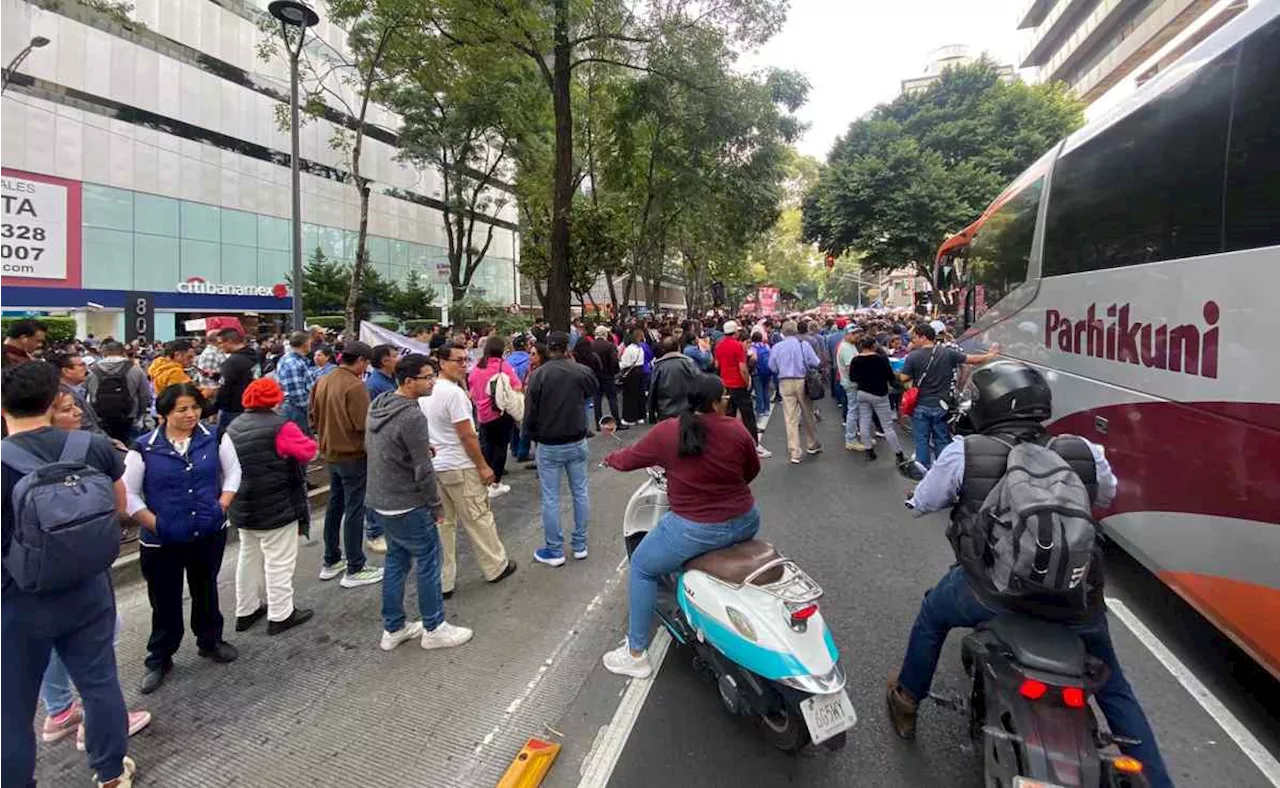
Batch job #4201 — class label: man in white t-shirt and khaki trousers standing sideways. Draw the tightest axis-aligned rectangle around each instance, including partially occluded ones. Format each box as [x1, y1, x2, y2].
[417, 343, 516, 599]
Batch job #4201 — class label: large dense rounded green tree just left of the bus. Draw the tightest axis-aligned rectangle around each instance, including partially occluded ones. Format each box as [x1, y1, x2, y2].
[804, 58, 1084, 282]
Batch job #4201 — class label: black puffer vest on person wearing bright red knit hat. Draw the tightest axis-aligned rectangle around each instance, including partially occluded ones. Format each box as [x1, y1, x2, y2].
[227, 411, 307, 531]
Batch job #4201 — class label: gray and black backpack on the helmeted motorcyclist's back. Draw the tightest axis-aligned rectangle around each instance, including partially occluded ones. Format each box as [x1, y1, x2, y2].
[974, 439, 1097, 596]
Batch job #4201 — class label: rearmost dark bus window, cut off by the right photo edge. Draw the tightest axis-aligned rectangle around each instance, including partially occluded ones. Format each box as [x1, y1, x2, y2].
[1225, 19, 1280, 251]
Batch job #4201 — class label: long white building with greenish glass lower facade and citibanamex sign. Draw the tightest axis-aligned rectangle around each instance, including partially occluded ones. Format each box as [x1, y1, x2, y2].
[0, 0, 520, 339]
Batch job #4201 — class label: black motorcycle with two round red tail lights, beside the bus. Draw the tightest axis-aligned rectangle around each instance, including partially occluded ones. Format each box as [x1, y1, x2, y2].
[932, 613, 1148, 788]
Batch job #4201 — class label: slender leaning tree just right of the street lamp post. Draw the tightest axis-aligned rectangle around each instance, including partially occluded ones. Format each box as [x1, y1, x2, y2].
[259, 0, 411, 336]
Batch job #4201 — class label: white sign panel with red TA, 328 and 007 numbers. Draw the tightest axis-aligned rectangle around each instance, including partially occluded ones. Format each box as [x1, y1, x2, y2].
[0, 174, 67, 279]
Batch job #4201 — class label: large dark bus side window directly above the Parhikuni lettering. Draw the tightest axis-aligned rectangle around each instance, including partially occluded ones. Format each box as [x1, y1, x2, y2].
[1043, 47, 1239, 276]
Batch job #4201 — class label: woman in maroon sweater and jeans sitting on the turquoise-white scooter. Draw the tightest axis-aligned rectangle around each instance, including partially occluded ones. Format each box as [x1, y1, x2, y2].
[604, 375, 760, 678]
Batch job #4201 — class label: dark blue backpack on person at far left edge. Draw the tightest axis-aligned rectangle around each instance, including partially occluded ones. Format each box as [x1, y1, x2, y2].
[0, 430, 120, 594]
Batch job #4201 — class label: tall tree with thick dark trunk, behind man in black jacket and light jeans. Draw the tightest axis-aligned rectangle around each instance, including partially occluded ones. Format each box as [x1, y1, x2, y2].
[421, 0, 786, 330]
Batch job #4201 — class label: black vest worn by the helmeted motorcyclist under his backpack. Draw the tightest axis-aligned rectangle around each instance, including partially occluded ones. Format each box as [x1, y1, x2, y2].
[947, 422, 1103, 622]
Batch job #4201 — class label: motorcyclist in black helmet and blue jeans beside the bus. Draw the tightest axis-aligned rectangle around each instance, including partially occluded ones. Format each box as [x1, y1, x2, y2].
[887, 361, 1172, 788]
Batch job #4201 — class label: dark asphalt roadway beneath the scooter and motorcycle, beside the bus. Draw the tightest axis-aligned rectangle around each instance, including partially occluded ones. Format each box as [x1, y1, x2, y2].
[548, 406, 1280, 788]
